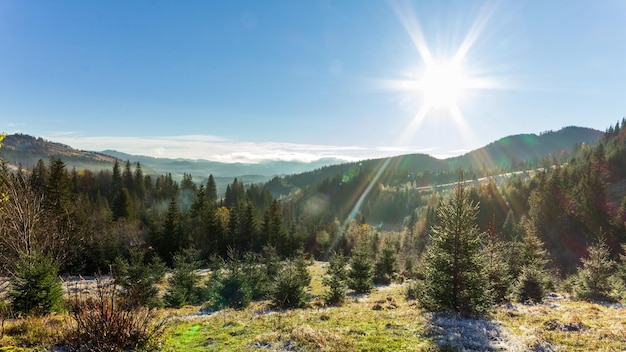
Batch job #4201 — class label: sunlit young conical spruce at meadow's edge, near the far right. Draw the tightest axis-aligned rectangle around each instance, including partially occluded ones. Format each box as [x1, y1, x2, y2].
[573, 240, 615, 301]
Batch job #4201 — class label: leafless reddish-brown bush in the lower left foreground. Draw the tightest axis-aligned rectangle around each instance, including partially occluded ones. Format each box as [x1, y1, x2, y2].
[68, 277, 167, 352]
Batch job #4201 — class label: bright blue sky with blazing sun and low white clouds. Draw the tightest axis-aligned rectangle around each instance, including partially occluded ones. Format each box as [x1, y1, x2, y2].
[0, 0, 626, 162]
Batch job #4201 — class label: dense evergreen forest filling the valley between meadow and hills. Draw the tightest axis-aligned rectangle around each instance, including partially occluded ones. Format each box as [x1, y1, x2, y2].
[0, 120, 626, 346]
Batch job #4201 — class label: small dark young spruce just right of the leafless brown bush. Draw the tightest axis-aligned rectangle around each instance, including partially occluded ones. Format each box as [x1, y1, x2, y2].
[163, 249, 202, 308]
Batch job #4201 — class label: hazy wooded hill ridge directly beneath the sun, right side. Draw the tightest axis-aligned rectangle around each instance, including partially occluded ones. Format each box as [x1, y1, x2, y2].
[270, 126, 604, 196]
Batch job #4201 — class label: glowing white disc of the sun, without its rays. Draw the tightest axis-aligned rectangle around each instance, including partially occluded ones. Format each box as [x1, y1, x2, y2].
[416, 61, 468, 110]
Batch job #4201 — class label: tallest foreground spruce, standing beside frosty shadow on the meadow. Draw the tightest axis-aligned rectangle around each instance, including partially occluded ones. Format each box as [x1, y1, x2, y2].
[418, 180, 492, 314]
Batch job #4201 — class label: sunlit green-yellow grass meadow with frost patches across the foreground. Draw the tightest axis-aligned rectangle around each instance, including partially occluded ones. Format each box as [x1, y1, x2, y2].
[0, 262, 626, 351]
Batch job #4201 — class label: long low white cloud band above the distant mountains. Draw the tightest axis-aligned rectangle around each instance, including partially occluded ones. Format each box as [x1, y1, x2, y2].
[44, 132, 428, 163]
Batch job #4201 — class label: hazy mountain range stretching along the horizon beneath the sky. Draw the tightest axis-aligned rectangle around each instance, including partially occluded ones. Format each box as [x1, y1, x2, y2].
[0, 127, 604, 184]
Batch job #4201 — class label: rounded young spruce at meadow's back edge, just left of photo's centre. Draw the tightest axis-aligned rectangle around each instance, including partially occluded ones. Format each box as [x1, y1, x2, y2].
[270, 259, 311, 309]
